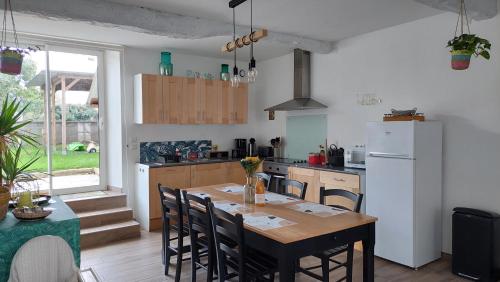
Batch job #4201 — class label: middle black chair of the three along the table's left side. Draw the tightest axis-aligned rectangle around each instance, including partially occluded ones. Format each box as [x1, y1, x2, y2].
[182, 191, 217, 282]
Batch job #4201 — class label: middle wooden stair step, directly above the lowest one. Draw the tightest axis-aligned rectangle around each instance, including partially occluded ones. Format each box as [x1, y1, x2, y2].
[77, 207, 133, 229]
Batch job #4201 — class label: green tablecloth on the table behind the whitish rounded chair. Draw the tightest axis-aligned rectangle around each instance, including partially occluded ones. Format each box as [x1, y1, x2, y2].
[0, 197, 80, 282]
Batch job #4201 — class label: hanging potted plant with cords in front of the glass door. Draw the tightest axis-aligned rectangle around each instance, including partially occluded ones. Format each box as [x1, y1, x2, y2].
[0, 0, 38, 75]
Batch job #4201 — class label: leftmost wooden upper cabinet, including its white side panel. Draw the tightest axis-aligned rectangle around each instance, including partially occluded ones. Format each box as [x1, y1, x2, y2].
[134, 74, 164, 123]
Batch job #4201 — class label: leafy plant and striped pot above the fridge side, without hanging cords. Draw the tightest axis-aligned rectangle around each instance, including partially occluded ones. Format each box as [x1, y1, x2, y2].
[447, 33, 491, 70]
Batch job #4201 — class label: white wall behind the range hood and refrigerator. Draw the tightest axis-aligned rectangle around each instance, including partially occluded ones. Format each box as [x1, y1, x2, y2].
[256, 13, 500, 252]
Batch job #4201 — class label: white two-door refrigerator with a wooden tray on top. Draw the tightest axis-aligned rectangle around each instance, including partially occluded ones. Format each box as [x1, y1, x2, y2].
[366, 121, 443, 268]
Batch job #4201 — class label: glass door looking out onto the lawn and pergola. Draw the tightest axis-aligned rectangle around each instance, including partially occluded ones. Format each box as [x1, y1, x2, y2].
[0, 41, 106, 195]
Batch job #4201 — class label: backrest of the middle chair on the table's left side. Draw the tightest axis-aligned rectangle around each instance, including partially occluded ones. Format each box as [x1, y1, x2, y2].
[182, 190, 213, 254]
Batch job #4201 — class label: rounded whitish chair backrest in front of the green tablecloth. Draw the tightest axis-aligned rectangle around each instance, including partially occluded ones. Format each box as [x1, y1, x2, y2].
[9, 235, 79, 282]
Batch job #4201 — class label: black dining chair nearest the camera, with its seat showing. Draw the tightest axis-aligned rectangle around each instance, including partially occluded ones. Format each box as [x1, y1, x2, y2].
[208, 203, 278, 282]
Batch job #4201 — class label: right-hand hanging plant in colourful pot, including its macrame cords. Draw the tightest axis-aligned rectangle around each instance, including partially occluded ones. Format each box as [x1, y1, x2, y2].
[447, 0, 491, 70]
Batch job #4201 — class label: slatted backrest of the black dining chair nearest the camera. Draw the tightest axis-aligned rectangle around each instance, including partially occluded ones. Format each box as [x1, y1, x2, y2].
[208, 203, 246, 281]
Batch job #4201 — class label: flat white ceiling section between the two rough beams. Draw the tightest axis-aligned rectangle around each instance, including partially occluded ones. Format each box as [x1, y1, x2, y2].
[111, 0, 442, 41]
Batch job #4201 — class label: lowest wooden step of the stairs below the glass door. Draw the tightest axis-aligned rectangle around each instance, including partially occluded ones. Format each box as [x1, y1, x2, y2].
[80, 220, 141, 249]
